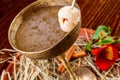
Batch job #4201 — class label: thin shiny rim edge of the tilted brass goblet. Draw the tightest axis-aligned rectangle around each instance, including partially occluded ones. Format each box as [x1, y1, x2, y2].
[8, 0, 81, 54]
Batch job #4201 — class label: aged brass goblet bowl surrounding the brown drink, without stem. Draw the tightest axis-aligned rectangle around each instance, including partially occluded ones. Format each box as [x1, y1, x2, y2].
[8, 0, 81, 59]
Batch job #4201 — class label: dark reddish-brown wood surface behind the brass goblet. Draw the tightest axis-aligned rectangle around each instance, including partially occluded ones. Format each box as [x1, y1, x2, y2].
[0, 0, 120, 74]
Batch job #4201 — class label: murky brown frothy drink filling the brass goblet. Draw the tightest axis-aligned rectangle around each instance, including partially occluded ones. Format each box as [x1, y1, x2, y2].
[15, 6, 65, 52]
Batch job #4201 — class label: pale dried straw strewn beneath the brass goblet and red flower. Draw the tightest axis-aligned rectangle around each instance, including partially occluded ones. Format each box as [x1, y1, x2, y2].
[0, 36, 120, 80]
